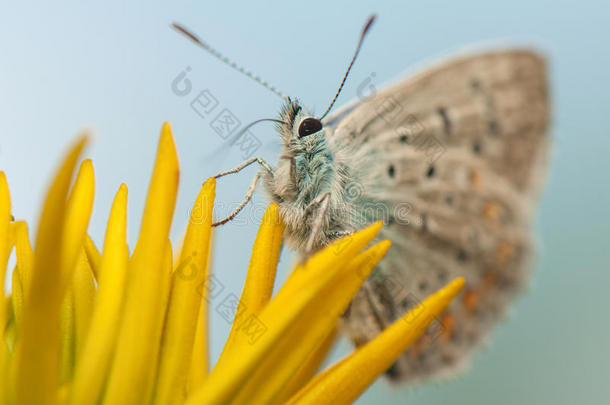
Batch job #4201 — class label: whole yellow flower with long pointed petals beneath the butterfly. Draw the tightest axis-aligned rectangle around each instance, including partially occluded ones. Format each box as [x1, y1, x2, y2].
[0, 124, 464, 405]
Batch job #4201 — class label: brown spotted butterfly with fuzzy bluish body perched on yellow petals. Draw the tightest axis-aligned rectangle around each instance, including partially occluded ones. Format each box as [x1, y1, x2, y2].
[174, 16, 550, 384]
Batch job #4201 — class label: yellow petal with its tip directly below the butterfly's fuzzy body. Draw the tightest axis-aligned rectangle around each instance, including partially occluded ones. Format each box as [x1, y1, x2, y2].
[218, 204, 284, 361]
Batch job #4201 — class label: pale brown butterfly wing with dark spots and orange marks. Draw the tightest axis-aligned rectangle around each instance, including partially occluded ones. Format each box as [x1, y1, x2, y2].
[325, 50, 549, 382]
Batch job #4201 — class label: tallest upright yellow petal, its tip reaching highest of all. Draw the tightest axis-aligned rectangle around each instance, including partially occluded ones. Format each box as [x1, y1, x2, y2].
[104, 124, 179, 405]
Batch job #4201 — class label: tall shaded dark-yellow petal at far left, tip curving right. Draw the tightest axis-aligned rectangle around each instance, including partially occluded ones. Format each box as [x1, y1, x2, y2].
[11, 138, 86, 405]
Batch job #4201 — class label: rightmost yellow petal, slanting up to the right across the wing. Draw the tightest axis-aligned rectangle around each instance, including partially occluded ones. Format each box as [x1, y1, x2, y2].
[288, 278, 464, 405]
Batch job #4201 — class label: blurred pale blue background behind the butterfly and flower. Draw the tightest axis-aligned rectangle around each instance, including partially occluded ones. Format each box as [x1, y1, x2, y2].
[0, 0, 610, 404]
